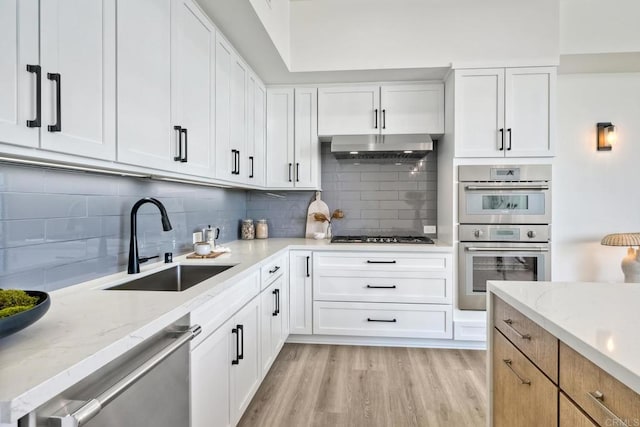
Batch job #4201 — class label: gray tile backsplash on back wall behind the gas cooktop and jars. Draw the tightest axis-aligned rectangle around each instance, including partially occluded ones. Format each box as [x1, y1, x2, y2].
[247, 143, 437, 237]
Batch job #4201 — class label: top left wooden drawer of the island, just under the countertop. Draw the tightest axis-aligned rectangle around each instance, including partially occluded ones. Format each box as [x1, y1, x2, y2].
[493, 295, 558, 384]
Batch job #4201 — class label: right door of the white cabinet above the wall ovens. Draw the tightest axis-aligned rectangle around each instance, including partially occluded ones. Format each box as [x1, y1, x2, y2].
[505, 67, 556, 157]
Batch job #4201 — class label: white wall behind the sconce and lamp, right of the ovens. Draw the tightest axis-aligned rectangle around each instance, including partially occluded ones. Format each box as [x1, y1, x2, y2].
[552, 73, 640, 281]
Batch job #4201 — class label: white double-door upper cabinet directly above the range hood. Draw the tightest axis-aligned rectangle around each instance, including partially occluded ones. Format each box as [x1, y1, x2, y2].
[318, 83, 444, 136]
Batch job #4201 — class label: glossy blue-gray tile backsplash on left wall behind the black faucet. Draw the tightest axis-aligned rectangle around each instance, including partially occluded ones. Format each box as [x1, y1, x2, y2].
[0, 164, 247, 291]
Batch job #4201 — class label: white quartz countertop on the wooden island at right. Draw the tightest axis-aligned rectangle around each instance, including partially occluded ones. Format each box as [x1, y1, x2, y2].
[488, 281, 640, 393]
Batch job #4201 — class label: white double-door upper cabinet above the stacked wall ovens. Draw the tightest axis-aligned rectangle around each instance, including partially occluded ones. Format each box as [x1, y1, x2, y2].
[455, 67, 556, 157]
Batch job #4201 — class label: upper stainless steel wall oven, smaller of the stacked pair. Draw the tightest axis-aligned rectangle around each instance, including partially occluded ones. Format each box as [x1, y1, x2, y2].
[458, 165, 551, 224]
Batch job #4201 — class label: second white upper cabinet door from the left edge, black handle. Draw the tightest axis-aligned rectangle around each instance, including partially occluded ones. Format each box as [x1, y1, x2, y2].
[40, 0, 116, 160]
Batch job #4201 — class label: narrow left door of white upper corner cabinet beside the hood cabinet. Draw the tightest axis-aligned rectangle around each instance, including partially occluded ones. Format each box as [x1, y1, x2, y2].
[267, 88, 294, 188]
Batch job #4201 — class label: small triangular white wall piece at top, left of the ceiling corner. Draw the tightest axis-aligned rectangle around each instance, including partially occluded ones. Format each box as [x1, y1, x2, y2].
[249, 0, 291, 67]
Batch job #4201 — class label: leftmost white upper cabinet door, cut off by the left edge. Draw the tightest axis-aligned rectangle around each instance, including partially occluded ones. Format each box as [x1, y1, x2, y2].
[0, 0, 41, 147]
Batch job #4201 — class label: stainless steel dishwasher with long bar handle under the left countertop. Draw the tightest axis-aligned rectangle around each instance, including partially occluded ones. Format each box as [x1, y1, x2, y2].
[23, 317, 200, 427]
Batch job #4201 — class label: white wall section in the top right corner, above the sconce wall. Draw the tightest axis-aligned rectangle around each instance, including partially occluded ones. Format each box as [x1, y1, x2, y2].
[560, 0, 640, 54]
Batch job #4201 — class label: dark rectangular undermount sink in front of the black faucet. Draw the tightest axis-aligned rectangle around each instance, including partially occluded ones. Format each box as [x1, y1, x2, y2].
[106, 265, 233, 292]
